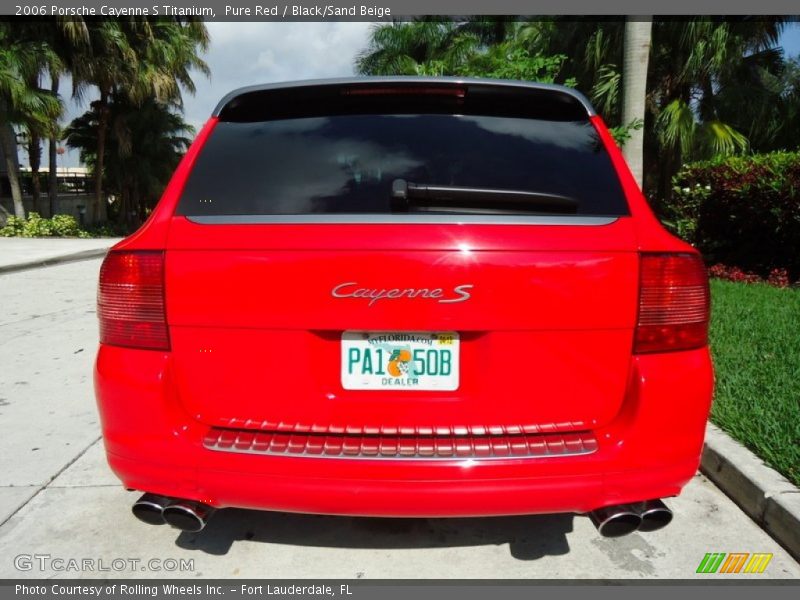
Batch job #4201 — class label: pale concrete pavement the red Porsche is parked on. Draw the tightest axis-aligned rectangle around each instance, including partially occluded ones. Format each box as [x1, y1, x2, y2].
[0, 260, 800, 579]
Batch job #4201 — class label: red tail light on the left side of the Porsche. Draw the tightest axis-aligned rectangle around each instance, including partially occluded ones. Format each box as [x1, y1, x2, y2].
[97, 251, 170, 350]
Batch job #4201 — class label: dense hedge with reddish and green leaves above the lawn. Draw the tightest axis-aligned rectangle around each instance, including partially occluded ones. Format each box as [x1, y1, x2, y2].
[664, 152, 800, 280]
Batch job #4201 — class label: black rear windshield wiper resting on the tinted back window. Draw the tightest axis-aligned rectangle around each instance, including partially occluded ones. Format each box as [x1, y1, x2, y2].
[392, 179, 578, 214]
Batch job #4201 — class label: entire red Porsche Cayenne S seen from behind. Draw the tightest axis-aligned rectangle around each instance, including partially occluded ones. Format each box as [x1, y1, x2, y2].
[95, 78, 713, 536]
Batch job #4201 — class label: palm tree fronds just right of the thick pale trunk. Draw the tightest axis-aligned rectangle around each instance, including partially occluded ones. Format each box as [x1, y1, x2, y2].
[645, 17, 786, 200]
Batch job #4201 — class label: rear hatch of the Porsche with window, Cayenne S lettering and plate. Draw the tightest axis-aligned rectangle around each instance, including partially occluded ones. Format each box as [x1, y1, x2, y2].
[166, 83, 638, 434]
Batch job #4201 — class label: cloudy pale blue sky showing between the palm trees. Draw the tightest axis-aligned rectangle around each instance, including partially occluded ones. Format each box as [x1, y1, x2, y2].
[31, 22, 800, 167]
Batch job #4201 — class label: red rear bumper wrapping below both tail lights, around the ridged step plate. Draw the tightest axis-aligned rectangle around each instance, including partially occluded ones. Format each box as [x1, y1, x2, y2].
[95, 346, 712, 517]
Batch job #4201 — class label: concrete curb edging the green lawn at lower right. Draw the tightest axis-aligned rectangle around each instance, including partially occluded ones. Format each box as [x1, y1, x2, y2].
[700, 423, 800, 560]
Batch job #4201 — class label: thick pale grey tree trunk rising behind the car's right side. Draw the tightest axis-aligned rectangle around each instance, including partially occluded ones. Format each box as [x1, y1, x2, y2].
[622, 17, 653, 187]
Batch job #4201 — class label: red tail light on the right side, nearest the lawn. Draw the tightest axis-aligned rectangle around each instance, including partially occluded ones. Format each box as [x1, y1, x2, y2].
[633, 253, 710, 354]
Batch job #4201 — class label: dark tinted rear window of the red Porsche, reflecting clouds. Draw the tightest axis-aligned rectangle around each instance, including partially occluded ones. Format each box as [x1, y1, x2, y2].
[178, 96, 627, 216]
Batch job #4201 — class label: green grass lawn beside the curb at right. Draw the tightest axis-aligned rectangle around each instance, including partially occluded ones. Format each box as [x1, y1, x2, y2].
[711, 280, 800, 485]
